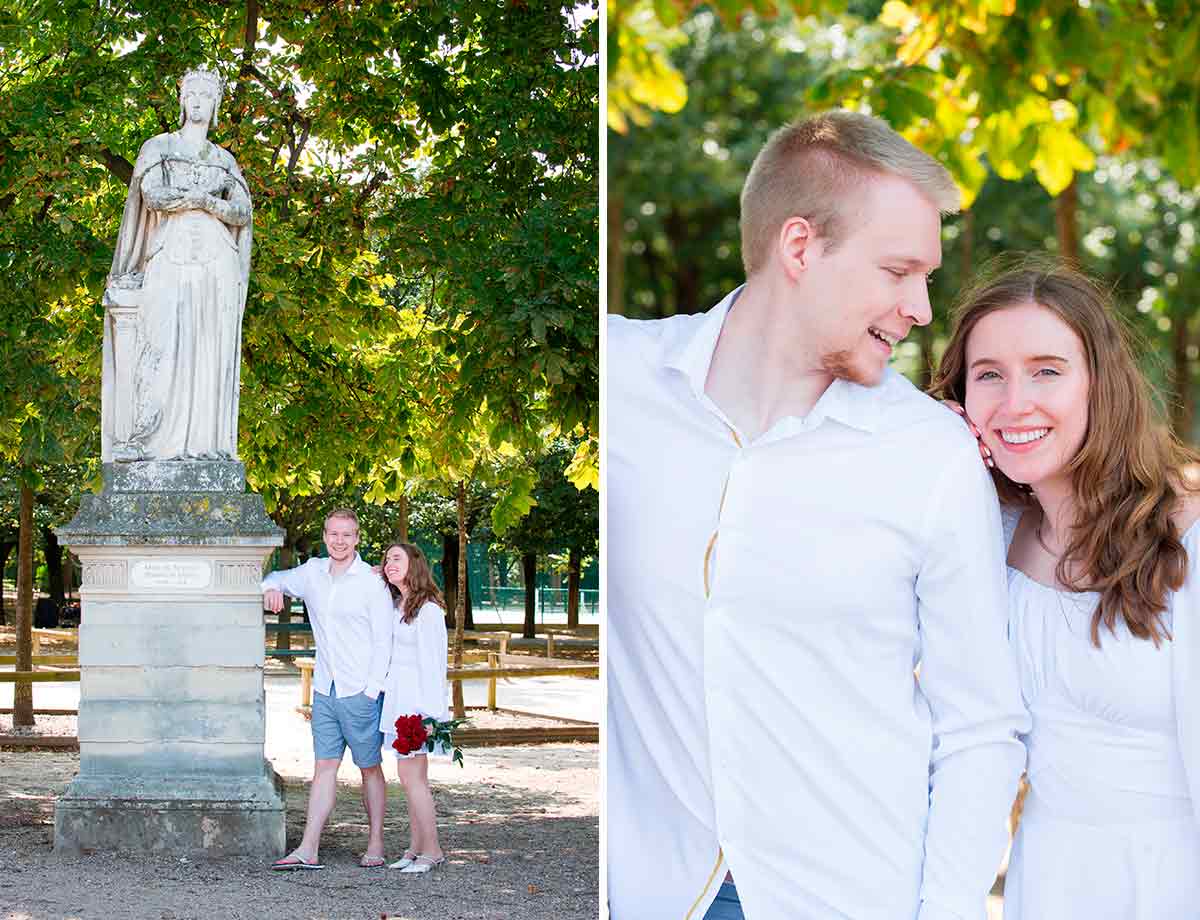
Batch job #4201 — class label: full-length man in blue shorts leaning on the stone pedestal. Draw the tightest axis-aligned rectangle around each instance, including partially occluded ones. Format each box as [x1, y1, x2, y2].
[263, 509, 395, 870]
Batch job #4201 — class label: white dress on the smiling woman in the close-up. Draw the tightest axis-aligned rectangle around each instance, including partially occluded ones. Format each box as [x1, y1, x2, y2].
[1004, 510, 1200, 920]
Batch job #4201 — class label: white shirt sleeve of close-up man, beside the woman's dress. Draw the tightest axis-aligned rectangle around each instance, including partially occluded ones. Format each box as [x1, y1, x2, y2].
[917, 440, 1028, 920]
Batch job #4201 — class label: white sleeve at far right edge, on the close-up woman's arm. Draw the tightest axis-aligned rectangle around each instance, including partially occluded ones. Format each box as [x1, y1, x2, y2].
[1171, 524, 1200, 830]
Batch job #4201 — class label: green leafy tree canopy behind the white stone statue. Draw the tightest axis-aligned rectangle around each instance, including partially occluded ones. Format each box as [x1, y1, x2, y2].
[0, 0, 599, 518]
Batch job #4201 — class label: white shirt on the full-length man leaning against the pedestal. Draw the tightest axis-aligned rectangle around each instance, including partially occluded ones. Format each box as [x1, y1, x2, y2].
[263, 555, 396, 699]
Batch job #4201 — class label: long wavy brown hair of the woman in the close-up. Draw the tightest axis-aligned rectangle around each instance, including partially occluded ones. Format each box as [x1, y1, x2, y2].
[930, 255, 1198, 648]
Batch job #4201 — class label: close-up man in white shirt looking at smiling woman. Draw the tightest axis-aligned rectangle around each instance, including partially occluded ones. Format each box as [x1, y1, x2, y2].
[606, 112, 1027, 920]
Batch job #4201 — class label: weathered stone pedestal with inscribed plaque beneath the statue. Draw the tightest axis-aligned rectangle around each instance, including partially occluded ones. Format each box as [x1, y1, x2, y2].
[54, 461, 284, 858]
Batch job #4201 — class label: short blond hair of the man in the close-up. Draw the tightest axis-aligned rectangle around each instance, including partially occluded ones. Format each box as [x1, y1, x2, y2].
[742, 109, 961, 277]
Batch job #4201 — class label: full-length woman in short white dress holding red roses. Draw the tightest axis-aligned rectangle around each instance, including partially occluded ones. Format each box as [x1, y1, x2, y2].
[379, 543, 449, 873]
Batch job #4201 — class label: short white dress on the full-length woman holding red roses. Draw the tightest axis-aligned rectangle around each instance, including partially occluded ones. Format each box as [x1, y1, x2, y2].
[379, 601, 450, 759]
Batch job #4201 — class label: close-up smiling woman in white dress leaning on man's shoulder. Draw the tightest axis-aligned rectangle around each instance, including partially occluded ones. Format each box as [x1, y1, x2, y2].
[935, 259, 1200, 920]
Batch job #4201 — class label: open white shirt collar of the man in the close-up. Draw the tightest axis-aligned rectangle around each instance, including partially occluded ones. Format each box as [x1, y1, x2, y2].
[664, 284, 878, 434]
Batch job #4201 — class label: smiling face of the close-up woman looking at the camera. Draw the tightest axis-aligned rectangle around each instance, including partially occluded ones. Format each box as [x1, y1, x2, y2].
[966, 302, 1088, 486]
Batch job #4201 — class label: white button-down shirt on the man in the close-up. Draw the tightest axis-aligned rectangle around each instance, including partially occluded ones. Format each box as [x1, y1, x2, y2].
[606, 291, 1028, 920]
